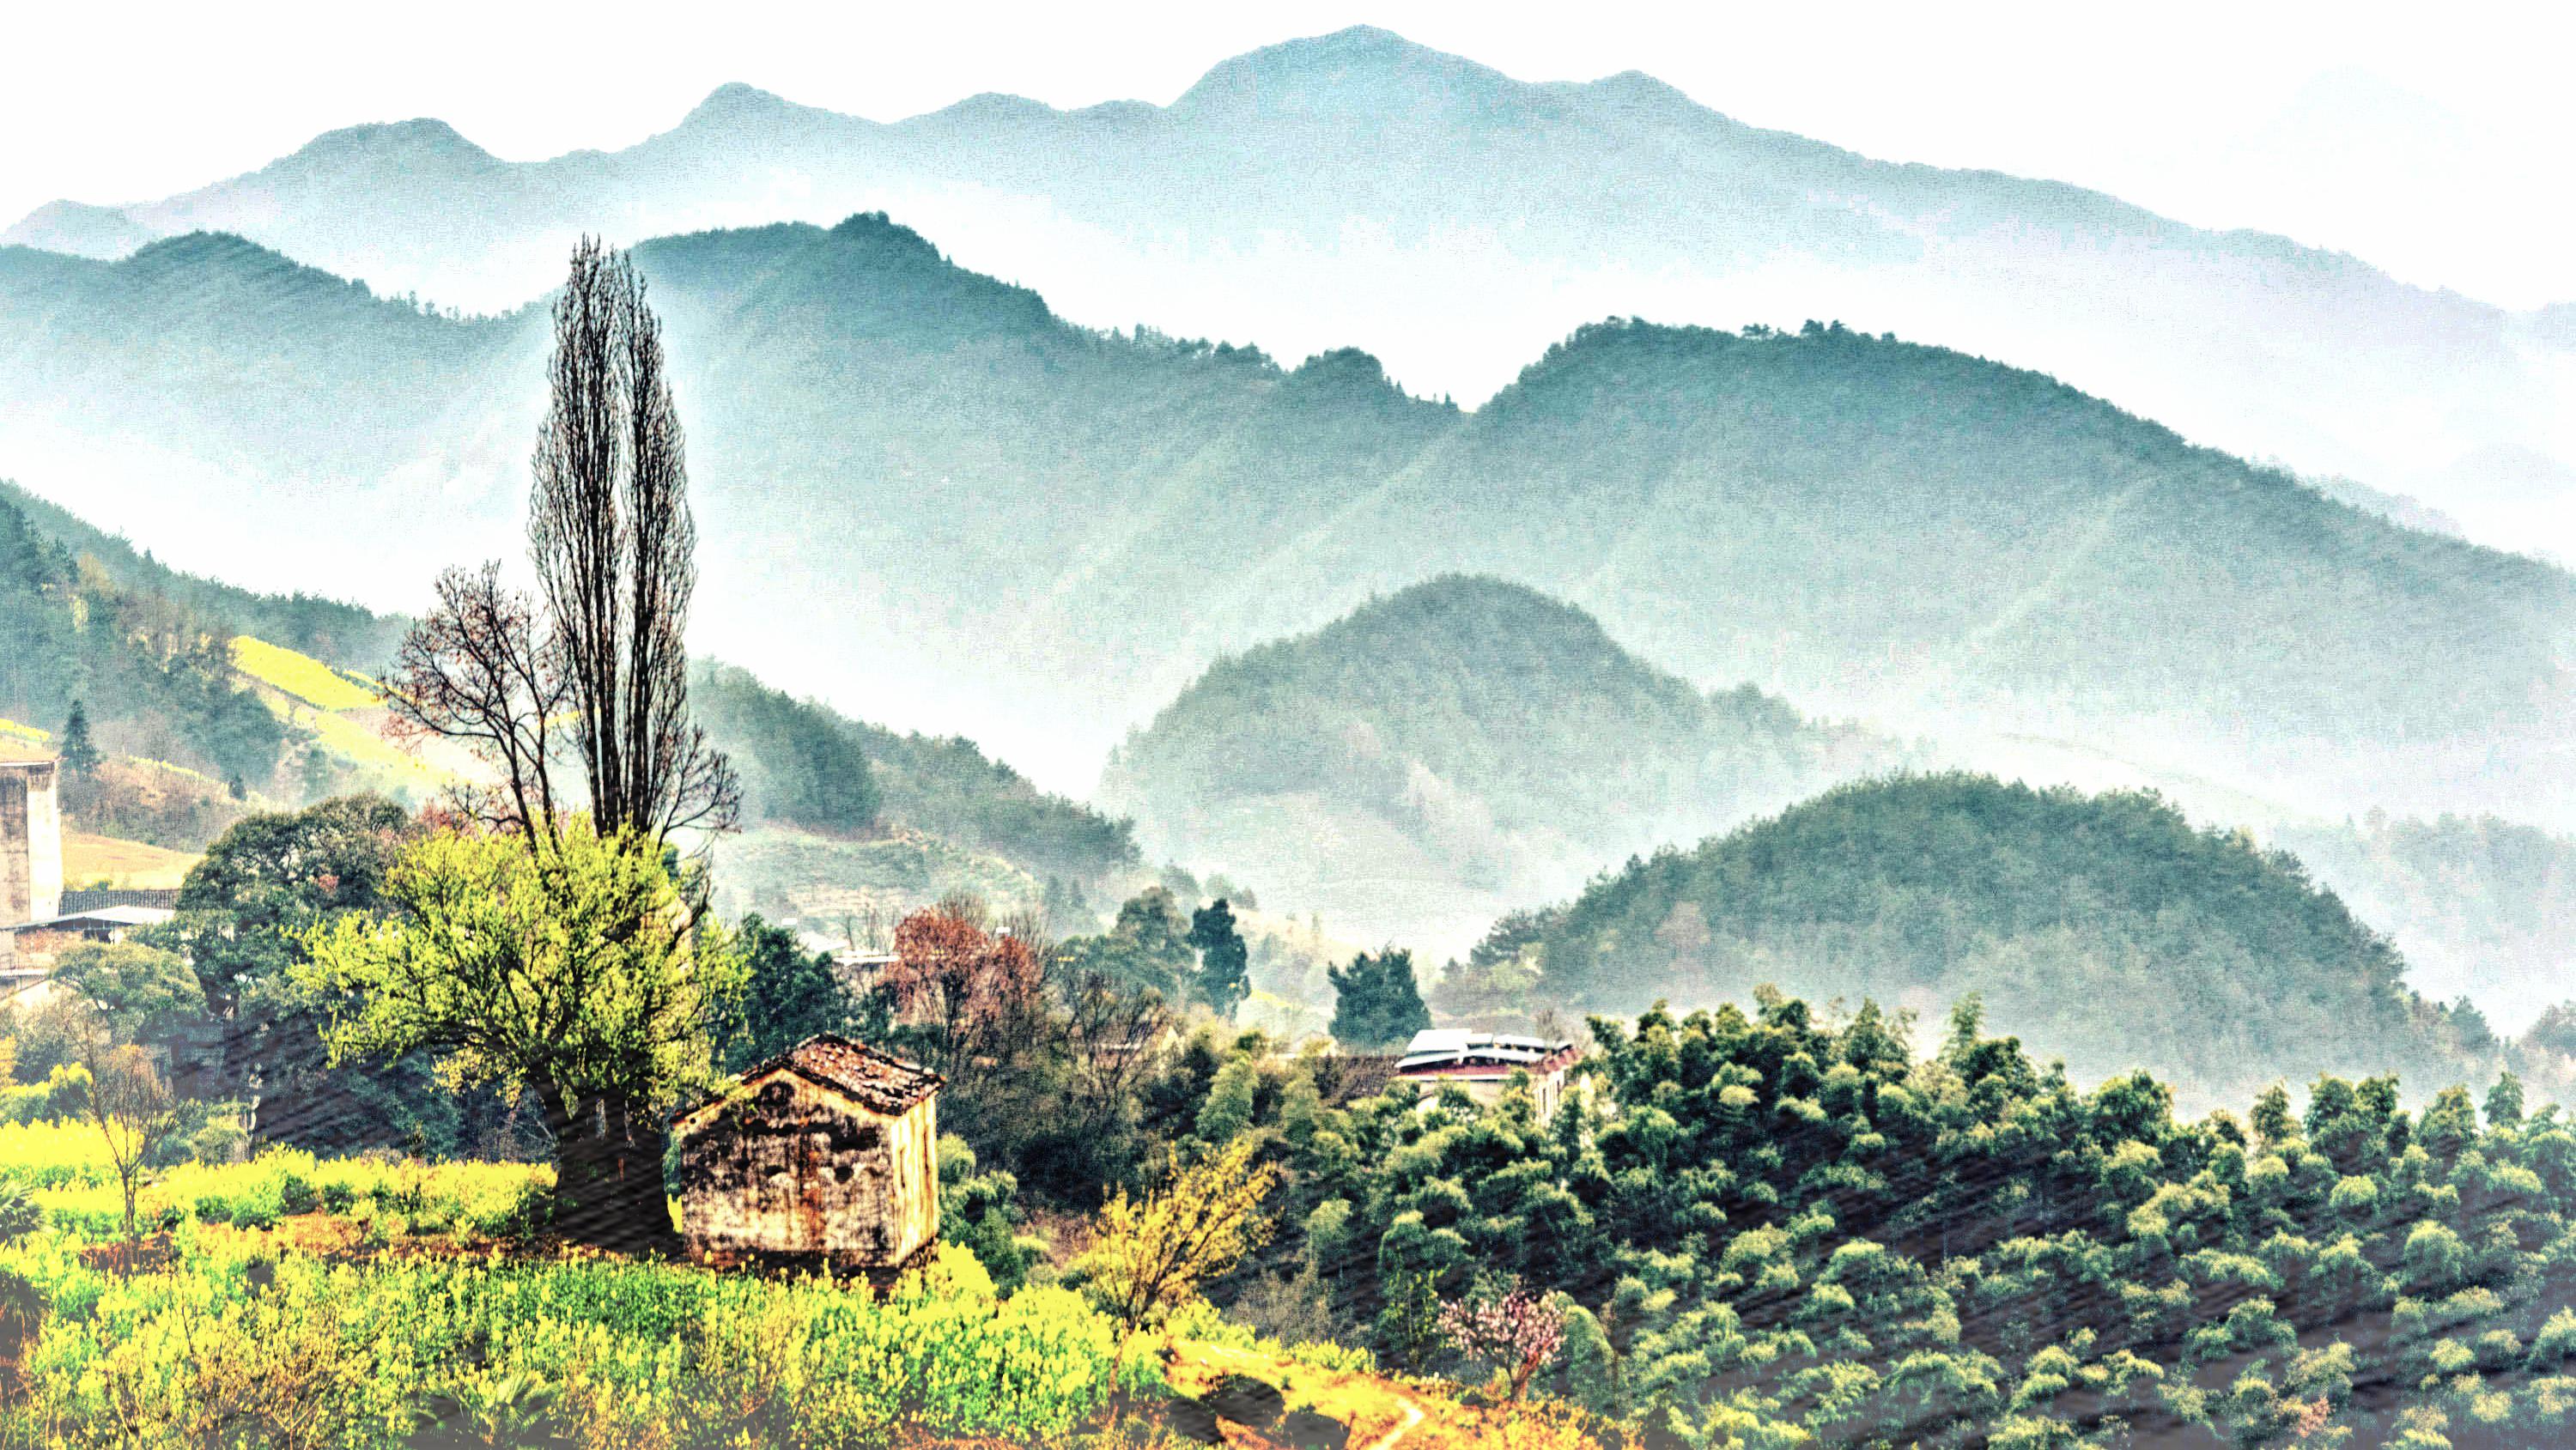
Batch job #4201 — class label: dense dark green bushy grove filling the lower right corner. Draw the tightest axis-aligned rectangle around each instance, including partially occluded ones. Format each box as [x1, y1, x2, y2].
[1285, 994, 2576, 1450]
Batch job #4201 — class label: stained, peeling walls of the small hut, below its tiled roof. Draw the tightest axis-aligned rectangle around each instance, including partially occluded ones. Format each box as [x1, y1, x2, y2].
[680, 1071, 938, 1267]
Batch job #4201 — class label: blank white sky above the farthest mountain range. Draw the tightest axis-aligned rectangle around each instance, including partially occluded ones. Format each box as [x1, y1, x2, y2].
[0, 0, 2576, 306]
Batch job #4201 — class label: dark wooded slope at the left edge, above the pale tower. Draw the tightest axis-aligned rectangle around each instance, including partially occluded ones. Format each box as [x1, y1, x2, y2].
[0, 500, 286, 793]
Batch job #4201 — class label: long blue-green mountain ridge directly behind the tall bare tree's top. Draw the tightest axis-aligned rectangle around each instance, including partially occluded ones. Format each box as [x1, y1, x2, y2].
[0, 216, 2576, 834]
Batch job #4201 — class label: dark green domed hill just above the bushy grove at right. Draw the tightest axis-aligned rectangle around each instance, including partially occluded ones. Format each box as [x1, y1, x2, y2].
[1479, 775, 2501, 1100]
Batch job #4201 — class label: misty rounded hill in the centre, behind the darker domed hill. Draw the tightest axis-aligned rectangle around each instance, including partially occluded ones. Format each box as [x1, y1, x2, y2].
[1103, 574, 1893, 950]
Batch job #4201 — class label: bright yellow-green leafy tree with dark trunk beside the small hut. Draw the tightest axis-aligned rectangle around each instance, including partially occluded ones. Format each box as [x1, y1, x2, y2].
[294, 816, 739, 1247]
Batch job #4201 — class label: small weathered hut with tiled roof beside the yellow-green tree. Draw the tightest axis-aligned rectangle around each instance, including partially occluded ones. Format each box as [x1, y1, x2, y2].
[672, 1035, 940, 1275]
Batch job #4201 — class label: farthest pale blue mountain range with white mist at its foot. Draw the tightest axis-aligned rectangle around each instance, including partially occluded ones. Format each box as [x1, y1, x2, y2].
[5, 28, 2576, 561]
